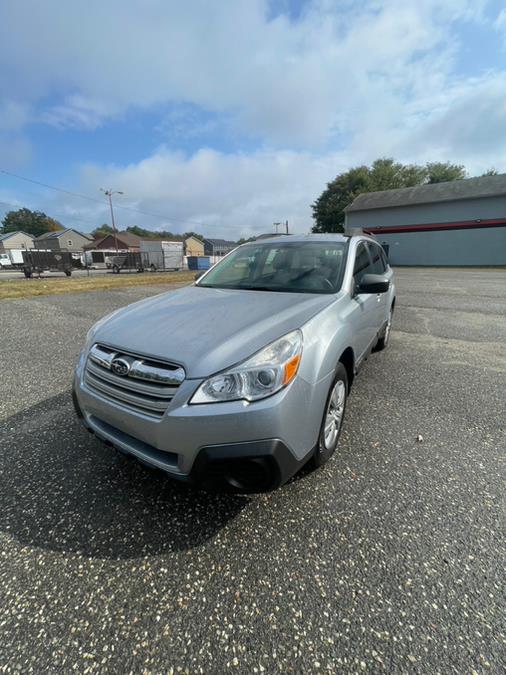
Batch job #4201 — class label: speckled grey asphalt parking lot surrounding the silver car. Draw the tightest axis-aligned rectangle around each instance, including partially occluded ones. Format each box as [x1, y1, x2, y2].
[0, 270, 506, 674]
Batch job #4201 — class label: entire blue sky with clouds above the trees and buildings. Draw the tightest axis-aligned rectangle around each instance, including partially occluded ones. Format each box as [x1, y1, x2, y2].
[0, 0, 506, 238]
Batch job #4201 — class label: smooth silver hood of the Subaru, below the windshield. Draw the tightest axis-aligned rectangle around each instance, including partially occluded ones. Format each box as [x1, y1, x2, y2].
[93, 286, 337, 378]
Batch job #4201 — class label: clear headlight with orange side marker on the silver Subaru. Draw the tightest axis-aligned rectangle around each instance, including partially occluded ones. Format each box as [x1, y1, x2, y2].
[190, 330, 302, 403]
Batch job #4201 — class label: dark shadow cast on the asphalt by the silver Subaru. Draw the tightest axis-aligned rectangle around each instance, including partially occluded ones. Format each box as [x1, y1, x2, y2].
[0, 392, 250, 559]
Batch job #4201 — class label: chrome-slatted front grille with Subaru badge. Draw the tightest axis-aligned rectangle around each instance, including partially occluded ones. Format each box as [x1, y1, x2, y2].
[85, 344, 185, 418]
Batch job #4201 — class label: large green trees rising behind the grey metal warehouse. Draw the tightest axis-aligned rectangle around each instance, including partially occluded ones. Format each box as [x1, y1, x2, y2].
[311, 157, 466, 232]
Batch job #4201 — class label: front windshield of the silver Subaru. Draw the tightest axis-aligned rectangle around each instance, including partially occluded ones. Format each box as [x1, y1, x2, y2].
[198, 242, 346, 293]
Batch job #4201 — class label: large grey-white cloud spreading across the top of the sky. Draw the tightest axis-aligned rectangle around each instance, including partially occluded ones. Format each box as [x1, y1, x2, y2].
[0, 0, 492, 148]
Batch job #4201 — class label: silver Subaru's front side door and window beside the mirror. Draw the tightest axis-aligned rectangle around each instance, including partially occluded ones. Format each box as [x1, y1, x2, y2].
[352, 241, 378, 363]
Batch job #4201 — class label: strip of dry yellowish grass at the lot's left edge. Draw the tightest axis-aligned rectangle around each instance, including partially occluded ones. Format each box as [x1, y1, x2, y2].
[0, 272, 195, 300]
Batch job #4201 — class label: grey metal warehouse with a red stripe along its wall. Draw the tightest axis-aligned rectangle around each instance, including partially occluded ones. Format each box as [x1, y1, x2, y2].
[345, 174, 506, 265]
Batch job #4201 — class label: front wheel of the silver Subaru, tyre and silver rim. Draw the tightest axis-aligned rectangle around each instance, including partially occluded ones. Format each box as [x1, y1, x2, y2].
[313, 363, 348, 467]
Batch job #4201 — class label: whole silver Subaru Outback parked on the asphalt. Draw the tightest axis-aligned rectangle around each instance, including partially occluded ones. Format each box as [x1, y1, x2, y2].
[73, 235, 395, 492]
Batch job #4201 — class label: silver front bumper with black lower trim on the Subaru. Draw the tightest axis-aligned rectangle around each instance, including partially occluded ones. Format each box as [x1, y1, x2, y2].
[73, 358, 329, 492]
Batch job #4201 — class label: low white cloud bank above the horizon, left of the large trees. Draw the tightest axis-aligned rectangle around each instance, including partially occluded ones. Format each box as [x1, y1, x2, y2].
[69, 149, 345, 238]
